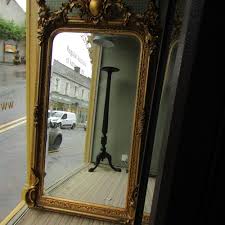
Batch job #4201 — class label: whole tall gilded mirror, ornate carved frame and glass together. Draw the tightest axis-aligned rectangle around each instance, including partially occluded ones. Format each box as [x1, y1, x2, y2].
[26, 0, 158, 224]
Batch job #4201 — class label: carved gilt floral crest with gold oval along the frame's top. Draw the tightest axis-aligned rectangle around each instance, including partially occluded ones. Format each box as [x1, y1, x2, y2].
[37, 0, 159, 49]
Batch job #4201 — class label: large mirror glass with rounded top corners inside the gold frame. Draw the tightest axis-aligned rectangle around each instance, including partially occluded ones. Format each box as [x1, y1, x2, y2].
[44, 32, 141, 208]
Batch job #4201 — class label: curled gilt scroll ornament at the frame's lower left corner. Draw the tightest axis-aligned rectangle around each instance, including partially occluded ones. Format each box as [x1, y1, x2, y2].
[25, 168, 40, 207]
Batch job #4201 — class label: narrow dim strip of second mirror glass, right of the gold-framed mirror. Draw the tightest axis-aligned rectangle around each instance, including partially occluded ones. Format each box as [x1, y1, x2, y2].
[144, 42, 177, 214]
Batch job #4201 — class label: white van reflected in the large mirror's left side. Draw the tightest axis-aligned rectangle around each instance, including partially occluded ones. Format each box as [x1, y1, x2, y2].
[49, 110, 77, 129]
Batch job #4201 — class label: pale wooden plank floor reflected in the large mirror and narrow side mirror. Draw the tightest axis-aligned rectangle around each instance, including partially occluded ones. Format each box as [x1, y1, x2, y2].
[47, 166, 155, 212]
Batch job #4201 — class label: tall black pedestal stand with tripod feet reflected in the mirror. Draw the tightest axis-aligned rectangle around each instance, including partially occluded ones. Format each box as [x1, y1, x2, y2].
[88, 66, 121, 172]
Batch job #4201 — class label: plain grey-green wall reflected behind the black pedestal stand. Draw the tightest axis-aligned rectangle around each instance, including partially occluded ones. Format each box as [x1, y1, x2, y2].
[92, 37, 140, 165]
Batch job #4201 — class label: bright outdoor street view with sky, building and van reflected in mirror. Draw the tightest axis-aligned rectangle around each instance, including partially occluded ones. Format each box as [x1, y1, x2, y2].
[45, 33, 91, 190]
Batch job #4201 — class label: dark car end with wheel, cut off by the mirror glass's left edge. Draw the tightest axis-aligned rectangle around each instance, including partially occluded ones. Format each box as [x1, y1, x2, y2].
[48, 112, 62, 151]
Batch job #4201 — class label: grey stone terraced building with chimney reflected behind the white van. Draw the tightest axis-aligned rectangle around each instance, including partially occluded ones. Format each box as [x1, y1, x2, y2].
[49, 60, 91, 123]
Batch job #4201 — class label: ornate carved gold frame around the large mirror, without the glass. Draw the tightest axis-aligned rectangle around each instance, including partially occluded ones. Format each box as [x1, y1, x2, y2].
[25, 0, 159, 224]
